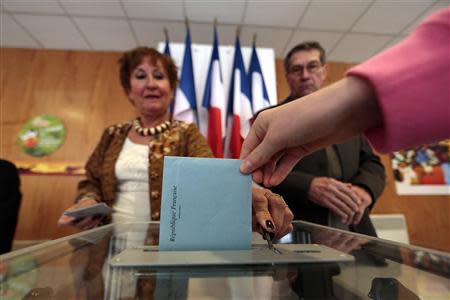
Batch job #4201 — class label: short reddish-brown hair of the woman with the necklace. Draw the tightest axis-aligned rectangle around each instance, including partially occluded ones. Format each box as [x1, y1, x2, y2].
[119, 47, 178, 93]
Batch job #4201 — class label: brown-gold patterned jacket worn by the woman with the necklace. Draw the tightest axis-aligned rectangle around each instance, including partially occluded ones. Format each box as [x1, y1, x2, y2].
[77, 121, 213, 221]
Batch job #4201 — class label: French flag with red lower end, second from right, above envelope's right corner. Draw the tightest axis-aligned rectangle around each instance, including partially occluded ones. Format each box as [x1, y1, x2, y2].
[227, 37, 253, 158]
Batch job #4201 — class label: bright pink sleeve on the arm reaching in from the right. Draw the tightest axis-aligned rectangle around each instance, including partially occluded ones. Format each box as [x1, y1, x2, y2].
[347, 8, 450, 152]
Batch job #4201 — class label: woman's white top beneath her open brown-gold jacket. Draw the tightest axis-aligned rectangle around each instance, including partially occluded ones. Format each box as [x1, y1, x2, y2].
[113, 138, 150, 222]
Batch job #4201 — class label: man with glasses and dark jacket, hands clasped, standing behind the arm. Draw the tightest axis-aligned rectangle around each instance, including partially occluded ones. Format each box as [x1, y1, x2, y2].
[272, 41, 385, 236]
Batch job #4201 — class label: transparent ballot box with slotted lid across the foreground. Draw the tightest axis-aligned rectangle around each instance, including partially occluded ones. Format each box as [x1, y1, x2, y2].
[0, 222, 450, 300]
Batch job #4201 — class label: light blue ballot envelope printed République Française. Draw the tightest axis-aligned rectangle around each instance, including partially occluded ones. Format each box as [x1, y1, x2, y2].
[159, 156, 252, 251]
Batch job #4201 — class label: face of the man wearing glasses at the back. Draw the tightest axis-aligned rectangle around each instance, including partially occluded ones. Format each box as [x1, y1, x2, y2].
[286, 49, 327, 97]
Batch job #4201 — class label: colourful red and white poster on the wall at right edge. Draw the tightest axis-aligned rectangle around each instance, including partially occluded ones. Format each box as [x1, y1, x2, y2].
[392, 140, 450, 195]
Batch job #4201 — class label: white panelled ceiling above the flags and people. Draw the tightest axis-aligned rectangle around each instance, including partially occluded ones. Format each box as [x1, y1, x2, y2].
[0, 0, 450, 62]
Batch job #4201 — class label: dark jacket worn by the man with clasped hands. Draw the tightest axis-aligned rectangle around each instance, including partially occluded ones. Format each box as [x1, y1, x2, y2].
[271, 99, 386, 236]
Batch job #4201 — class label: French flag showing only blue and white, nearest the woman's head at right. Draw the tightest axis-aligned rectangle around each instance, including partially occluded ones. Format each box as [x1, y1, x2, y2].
[172, 29, 197, 124]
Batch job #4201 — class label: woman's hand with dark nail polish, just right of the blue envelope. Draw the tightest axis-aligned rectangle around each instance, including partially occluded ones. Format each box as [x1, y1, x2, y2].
[252, 187, 294, 239]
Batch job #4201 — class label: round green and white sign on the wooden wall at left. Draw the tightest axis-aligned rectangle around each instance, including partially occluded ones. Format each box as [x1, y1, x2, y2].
[18, 115, 66, 156]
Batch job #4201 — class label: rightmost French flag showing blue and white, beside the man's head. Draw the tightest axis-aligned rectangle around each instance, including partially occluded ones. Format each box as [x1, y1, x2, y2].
[248, 42, 270, 115]
